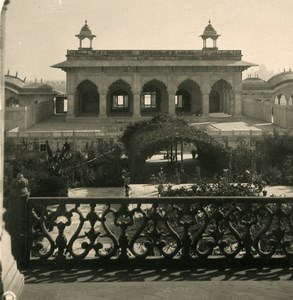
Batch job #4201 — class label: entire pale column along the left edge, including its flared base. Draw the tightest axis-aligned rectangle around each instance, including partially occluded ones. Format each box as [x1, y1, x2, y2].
[0, 1, 24, 299]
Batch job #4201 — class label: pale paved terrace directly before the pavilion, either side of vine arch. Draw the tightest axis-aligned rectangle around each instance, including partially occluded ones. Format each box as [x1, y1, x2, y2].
[8, 113, 275, 137]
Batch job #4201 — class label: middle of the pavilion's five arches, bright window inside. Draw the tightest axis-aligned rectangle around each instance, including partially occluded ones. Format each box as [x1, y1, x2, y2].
[140, 79, 168, 115]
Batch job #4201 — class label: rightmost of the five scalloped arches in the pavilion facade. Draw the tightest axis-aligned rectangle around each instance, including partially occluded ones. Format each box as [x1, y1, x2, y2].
[209, 79, 234, 114]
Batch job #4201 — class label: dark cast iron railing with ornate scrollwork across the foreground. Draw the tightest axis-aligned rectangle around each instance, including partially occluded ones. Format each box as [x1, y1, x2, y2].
[26, 197, 293, 262]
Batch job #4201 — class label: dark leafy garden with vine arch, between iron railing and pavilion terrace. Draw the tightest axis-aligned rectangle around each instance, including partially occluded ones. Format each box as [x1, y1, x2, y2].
[5, 115, 293, 197]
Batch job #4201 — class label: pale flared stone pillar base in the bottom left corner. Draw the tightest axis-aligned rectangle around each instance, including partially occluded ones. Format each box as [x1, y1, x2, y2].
[0, 229, 24, 299]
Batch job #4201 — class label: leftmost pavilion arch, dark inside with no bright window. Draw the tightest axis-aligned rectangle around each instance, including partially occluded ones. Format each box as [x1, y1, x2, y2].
[75, 79, 100, 117]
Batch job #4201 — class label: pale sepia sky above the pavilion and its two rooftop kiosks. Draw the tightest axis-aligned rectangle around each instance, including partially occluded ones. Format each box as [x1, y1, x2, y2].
[2, 0, 293, 81]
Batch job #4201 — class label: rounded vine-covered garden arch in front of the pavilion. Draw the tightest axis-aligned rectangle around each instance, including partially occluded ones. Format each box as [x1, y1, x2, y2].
[121, 115, 228, 182]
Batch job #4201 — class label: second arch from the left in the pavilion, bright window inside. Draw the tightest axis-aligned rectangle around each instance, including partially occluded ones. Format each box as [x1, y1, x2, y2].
[107, 79, 133, 116]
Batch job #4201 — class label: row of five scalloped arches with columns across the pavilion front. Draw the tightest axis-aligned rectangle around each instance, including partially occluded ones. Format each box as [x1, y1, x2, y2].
[68, 79, 234, 117]
